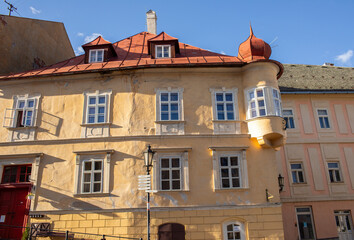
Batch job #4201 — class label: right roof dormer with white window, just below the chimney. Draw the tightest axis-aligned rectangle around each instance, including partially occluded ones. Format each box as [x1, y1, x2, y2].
[148, 32, 180, 58]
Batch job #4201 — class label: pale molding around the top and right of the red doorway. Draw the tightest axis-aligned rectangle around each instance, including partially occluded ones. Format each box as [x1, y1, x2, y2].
[0, 153, 44, 211]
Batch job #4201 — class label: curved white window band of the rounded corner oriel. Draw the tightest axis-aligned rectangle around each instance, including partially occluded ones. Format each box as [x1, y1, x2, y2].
[245, 87, 282, 119]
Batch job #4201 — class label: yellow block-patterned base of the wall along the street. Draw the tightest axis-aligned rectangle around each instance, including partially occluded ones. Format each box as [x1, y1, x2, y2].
[31, 206, 284, 240]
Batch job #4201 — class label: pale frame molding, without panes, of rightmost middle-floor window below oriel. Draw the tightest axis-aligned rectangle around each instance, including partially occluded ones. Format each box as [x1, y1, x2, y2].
[209, 147, 249, 191]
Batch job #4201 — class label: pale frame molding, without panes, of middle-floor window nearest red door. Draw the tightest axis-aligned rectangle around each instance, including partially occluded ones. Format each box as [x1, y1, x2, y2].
[73, 149, 114, 196]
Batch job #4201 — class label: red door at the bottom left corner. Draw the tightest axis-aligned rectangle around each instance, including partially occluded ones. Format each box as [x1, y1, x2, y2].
[0, 188, 28, 239]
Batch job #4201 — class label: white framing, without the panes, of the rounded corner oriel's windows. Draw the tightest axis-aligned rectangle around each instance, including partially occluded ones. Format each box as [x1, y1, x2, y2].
[244, 86, 282, 120]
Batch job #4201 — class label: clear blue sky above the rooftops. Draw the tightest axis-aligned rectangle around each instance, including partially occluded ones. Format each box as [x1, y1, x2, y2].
[0, 0, 354, 67]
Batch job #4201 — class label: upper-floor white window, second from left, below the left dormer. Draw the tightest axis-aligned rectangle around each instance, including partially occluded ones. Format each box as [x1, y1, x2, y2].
[83, 90, 112, 124]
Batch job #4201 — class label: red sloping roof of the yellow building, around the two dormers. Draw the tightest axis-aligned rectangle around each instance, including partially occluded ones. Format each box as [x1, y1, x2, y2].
[0, 32, 282, 80]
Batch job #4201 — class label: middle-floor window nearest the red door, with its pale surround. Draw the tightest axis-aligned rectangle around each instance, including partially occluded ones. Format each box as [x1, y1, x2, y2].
[74, 149, 114, 195]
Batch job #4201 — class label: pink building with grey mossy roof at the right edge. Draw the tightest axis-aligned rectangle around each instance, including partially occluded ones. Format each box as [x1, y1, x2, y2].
[277, 65, 354, 240]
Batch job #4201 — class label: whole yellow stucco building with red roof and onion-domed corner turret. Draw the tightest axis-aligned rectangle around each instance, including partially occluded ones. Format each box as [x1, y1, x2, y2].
[0, 15, 285, 240]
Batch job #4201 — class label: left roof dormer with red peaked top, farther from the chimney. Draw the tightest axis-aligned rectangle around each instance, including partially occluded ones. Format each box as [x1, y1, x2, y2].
[82, 36, 117, 63]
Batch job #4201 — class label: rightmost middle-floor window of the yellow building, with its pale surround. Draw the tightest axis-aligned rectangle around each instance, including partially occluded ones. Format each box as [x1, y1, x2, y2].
[210, 147, 248, 189]
